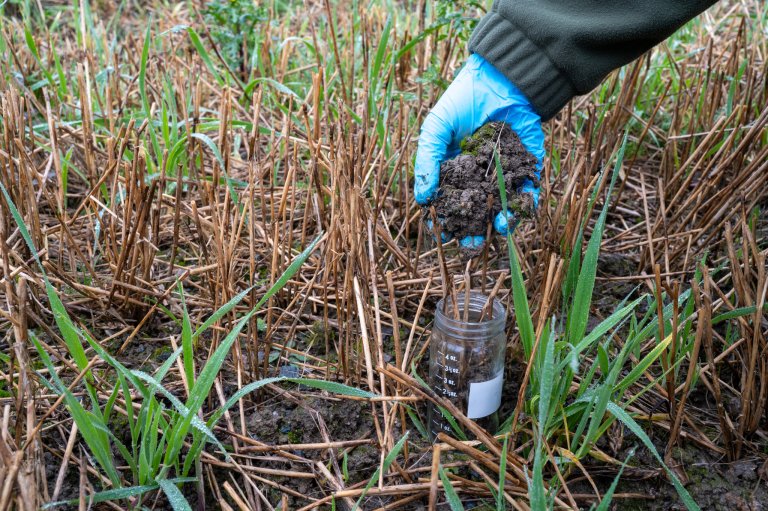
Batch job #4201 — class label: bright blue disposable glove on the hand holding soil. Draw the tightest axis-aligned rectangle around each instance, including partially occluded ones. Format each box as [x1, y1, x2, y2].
[414, 53, 544, 248]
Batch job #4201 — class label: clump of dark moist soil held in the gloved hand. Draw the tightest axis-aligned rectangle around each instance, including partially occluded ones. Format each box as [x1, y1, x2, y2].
[425, 122, 538, 246]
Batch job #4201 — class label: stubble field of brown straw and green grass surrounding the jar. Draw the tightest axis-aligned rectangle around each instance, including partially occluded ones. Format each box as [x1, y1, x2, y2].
[0, 0, 768, 511]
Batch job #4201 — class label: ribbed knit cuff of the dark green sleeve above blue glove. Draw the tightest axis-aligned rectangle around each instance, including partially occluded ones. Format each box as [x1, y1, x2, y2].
[469, 11, 577, 121]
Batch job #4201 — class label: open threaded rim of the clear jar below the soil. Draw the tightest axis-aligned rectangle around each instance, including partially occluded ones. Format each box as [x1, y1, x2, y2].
[435, 292, 507, 334]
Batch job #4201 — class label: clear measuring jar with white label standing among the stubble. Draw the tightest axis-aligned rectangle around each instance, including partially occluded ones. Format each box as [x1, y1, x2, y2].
[427, 292, 507, 440]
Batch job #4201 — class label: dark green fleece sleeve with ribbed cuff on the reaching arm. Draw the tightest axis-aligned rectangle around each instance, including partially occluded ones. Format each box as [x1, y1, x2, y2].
[469, 0, 716, 120]
